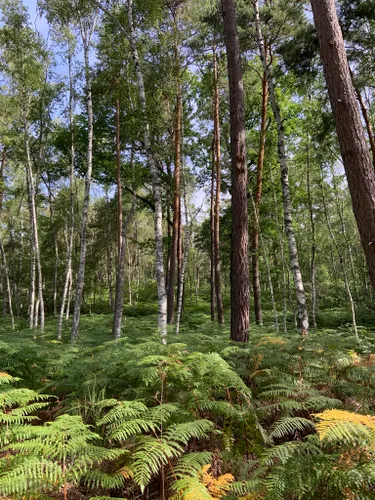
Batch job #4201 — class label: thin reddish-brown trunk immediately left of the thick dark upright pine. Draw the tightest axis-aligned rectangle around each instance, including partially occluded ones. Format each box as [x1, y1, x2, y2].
[213, 47, 224, 325]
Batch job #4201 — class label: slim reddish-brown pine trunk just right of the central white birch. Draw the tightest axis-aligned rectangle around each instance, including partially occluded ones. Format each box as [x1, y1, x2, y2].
[167, 38, 182, 325]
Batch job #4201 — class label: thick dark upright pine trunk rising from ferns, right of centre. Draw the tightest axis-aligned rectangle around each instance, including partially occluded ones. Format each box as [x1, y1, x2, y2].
[221, 0, 250, 342]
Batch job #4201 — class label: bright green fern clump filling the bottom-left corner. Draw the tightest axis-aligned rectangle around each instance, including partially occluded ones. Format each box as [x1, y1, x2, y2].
[0, 415, 122, 495]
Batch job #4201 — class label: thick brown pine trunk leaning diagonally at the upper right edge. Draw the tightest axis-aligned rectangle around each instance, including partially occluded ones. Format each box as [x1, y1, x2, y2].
[311, 0, 375, 288]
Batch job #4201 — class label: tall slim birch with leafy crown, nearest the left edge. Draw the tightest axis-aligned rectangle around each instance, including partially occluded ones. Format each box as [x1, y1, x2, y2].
[0, 0, 48, 330]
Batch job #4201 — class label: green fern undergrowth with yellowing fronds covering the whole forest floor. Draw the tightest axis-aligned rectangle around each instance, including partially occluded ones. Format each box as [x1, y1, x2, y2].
[0, 309, 375, 500]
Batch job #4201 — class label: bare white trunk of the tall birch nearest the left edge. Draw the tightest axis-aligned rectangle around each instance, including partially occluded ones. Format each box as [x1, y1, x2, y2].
[23, 109, 44, 331]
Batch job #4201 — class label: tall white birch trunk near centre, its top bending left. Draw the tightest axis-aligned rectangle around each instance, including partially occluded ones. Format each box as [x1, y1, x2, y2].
[128, 0, 167, 343]
